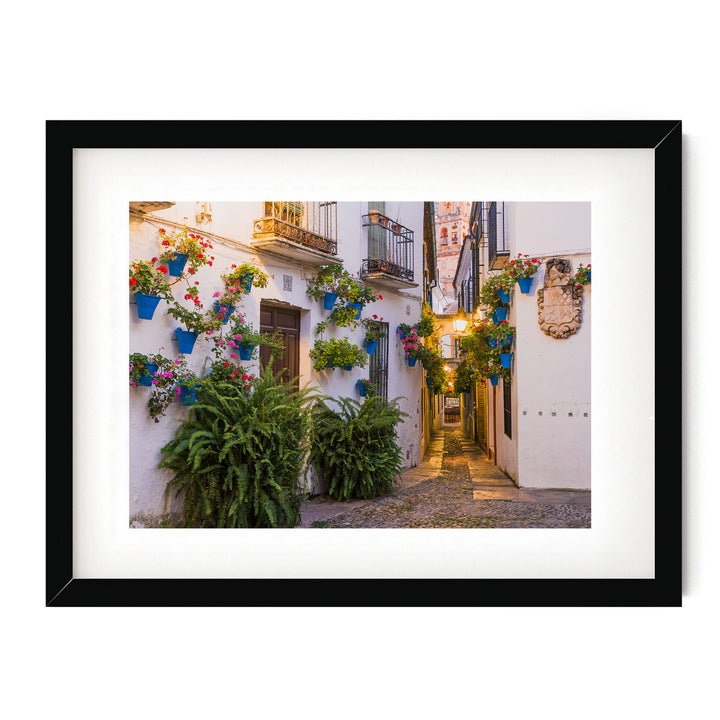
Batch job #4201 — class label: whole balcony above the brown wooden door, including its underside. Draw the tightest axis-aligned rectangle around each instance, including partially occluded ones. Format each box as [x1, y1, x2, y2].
[251, 200, 340, 264]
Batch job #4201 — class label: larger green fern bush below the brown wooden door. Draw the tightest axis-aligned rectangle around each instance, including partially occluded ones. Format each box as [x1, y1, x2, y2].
[159, 368, 314, 528]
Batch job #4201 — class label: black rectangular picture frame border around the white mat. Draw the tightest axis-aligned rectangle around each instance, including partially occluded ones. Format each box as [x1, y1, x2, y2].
[46, 120, 682, 607]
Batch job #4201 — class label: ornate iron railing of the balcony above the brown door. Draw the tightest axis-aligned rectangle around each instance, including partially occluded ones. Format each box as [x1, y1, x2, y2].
[252, 200, 337, 255]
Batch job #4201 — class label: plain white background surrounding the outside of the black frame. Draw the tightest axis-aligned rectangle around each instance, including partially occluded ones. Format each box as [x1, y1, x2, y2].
[0, 0, 720, 718]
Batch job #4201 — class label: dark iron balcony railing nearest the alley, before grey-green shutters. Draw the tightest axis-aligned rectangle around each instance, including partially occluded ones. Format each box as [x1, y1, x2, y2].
[360, 211, 415, 283]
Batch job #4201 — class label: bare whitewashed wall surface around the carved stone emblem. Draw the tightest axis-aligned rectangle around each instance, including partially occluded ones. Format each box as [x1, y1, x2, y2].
[495, 202, 592, 488]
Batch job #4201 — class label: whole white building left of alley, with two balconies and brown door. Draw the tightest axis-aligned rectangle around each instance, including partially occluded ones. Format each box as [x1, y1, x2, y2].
[129, 201, 425, 520]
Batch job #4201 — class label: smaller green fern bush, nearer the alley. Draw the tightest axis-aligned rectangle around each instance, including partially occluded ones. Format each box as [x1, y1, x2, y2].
[310, 395, 409, 500]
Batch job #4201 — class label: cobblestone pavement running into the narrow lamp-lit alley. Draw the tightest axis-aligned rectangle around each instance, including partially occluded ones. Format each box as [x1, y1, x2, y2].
[300, 430, 590, 528]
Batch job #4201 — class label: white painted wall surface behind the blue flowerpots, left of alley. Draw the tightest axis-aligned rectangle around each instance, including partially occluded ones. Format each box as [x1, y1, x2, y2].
[129, 201, 424, 520]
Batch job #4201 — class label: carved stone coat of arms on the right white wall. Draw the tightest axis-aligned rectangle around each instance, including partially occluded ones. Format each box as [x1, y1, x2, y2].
[537, 258, 583, 340]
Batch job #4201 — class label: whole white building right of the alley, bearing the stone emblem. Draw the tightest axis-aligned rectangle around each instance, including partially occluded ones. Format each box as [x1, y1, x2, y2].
[455, 202, 592, 489]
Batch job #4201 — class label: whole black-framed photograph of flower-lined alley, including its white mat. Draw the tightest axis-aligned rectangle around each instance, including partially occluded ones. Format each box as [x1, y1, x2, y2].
[46, 121, 682, 607]
